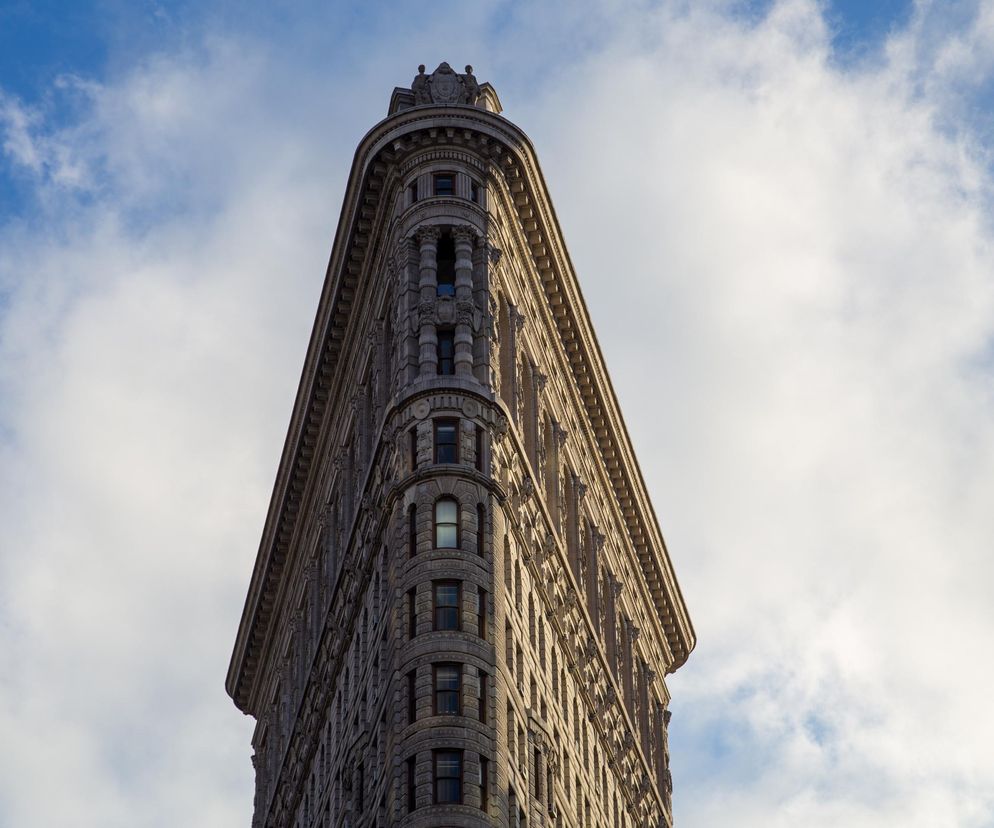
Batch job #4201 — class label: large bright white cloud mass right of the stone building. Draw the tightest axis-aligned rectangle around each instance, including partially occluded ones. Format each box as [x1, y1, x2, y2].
[524, 2, 994, 826]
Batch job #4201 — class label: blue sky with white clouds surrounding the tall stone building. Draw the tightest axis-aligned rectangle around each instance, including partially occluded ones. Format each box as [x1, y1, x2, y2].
[0, 0, 994, 828]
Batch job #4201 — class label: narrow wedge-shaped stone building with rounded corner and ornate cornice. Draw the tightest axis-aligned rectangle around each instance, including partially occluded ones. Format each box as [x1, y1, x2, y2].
[227, 63, 694, 828]
